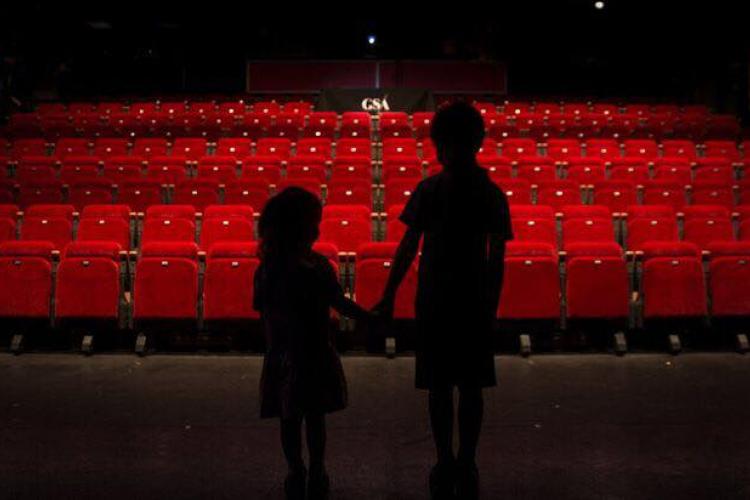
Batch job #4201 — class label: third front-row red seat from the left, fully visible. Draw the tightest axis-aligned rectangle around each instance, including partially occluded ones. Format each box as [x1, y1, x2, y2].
[133, 242, 198, 321]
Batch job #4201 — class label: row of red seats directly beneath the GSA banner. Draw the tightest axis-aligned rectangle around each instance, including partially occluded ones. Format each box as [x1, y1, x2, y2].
[8, 108, 740, 140]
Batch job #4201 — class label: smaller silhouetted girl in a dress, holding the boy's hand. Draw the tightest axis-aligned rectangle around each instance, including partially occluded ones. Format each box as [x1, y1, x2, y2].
[254, 187, 369, 499]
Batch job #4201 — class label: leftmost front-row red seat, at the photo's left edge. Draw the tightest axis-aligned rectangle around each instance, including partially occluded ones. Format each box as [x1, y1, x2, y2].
[0, 241, 54, 319]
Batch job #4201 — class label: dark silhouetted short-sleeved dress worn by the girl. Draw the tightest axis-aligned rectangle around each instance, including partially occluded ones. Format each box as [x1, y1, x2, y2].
[253, 252, 347, 419]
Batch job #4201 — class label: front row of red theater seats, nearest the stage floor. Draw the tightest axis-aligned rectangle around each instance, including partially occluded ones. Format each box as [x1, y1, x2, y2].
[0, 242, 750, 328]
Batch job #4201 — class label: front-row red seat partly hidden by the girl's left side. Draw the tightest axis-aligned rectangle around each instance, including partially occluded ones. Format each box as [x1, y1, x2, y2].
[203, 242, 260, 321]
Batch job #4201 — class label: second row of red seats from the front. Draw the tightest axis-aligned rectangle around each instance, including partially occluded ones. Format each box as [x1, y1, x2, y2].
[0, 201, 750, 253]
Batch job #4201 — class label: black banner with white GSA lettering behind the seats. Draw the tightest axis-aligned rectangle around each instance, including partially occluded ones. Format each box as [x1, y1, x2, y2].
[315, 89, 435, 114]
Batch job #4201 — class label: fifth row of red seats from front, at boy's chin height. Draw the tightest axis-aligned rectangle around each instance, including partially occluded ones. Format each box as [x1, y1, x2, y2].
[0, 137, 750, 163]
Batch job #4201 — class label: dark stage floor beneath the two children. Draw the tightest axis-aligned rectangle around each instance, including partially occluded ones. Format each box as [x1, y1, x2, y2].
[0, 353, 750, 500]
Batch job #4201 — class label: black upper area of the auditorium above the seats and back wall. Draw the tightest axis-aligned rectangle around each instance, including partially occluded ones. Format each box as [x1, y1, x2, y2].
[0, 0, 750, 113]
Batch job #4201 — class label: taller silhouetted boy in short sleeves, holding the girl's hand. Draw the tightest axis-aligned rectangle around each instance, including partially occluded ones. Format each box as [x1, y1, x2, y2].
[375, 102, 512, 499]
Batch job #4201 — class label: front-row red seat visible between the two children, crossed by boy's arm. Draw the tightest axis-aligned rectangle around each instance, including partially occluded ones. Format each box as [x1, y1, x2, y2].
[354, 242, 417, 319]
